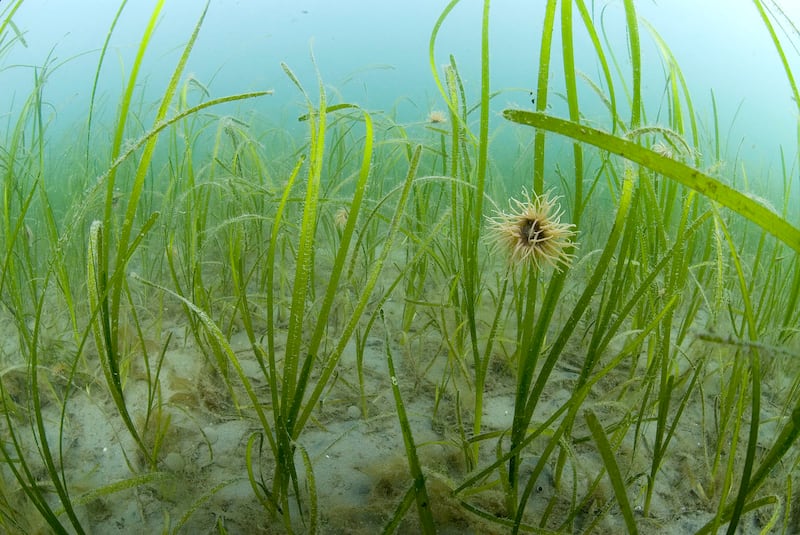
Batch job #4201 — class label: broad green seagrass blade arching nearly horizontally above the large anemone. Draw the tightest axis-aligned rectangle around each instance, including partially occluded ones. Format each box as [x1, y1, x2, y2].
[503, 109, 800, 253]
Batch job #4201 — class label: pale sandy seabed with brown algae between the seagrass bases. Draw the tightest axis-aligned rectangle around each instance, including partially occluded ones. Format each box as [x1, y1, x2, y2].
[3, 288, 788, 534]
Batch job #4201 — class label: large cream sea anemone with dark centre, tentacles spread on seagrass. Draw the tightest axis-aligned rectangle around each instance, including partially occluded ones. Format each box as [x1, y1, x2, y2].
[489, 190, 575, 269]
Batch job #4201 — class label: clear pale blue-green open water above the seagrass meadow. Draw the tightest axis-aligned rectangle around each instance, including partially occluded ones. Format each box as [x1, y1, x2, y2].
[6, 0, 798, 202]
